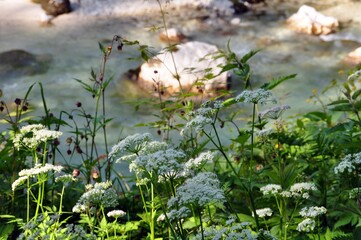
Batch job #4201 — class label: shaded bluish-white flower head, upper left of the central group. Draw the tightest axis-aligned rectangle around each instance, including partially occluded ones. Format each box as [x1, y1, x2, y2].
[109, 133, 152, 160]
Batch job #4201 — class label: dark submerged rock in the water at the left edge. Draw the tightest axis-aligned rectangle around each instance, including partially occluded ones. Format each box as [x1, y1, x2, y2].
[0, 50, 51, 79]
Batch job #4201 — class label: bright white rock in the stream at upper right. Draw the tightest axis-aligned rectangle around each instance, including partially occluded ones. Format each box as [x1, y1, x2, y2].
[287, 5, 339, 35]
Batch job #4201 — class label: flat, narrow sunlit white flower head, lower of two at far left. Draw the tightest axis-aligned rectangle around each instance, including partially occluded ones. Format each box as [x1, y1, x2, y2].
[11, 163, 63, 191]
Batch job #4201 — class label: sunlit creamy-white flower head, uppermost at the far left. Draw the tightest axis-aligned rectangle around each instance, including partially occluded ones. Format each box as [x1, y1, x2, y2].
[13, 124, 63, 149]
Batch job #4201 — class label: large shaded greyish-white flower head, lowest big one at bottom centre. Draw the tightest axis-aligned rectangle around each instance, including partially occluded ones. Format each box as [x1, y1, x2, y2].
[168, 172, 225, 218]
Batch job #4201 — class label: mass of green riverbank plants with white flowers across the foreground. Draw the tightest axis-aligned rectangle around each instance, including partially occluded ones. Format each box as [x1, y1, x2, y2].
[0, 1, 361, 240]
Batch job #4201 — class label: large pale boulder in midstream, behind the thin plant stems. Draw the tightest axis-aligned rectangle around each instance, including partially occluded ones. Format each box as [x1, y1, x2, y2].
[138, 41, 229, 95]
